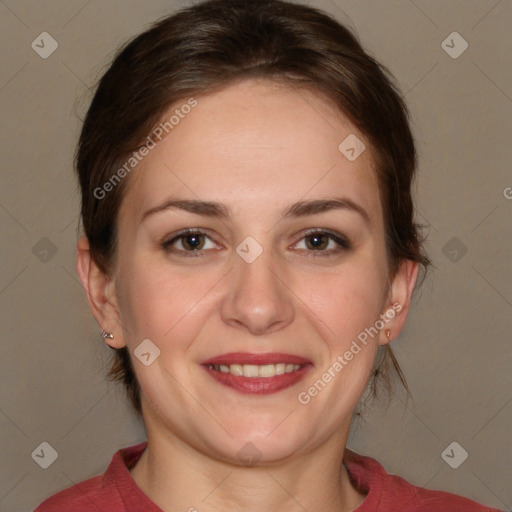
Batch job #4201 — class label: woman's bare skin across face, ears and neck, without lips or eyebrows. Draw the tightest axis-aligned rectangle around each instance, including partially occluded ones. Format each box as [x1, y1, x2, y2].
[77, 80, 418, 512]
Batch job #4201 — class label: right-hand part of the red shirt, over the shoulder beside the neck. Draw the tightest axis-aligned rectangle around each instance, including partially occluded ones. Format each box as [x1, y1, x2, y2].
[344, 449, 499, 512]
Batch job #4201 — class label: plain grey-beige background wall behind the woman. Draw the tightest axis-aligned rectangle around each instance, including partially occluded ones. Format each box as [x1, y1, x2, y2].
[0, 0, 512, 512]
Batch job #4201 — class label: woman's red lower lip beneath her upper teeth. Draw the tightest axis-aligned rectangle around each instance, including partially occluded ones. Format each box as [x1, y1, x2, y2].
[203, 364, 312, 395]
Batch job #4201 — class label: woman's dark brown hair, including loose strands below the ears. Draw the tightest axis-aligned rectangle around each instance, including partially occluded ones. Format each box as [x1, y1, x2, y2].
[75, 0, 430, 413]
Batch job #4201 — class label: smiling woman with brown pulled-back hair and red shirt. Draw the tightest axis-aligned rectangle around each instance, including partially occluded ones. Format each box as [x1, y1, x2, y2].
[36, 0, 504, 512]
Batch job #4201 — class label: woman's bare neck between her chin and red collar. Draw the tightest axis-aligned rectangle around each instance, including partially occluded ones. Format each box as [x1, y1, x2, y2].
[131, 414, 365, 512]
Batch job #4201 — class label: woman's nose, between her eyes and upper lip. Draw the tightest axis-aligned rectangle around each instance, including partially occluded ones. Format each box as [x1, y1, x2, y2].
[220, 250, 295, 334]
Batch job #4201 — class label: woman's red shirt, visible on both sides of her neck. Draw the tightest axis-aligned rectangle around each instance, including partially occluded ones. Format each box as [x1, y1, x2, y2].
[34, 442, 499, 512]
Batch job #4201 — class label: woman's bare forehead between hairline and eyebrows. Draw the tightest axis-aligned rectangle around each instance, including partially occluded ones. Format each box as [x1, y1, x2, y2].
[123, 80, 380, 223]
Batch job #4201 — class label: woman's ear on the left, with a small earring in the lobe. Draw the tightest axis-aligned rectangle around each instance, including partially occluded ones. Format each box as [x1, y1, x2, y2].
[76, 236, 125, 348]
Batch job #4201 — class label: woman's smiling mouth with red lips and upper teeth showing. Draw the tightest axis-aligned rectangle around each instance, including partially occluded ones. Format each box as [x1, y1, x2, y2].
[202, 352, 313, 395]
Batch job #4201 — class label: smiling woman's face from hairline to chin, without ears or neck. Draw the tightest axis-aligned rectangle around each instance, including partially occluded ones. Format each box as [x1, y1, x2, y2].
[111, 81, 404, 462]
